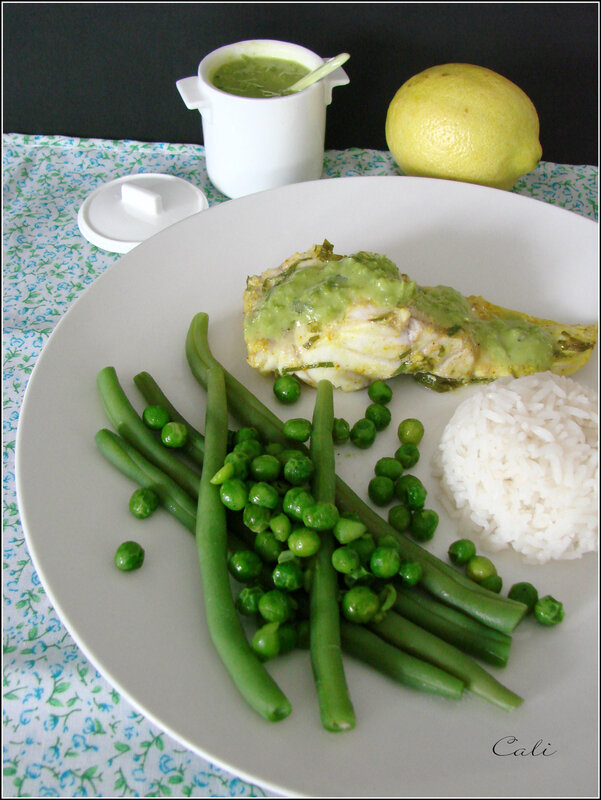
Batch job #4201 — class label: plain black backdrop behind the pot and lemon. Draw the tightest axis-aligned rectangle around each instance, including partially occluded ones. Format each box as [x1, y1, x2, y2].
[3, 3, 599, 164]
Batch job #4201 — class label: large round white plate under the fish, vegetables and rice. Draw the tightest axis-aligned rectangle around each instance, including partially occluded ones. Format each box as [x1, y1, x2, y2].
[17, 177, 598, 797]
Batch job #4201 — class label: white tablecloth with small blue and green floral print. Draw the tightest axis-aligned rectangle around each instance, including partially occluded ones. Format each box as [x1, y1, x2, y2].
[2, 133, 598, 797]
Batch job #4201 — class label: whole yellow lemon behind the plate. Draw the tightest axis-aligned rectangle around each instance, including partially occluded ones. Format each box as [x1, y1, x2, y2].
[386, 64, 542, 189]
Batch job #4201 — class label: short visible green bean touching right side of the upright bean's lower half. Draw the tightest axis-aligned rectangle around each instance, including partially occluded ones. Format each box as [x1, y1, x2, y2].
[340, 622, 464, 700]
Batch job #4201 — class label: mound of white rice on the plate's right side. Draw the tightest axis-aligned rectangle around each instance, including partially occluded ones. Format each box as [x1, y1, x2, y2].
[434, 372, 599, 564]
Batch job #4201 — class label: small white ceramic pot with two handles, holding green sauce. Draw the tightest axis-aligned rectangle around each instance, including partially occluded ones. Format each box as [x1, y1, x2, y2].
[176, 39, 349, 197]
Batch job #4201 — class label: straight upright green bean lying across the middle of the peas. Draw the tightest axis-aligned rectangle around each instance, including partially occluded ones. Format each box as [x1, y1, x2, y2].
[310, 380, 355, 731]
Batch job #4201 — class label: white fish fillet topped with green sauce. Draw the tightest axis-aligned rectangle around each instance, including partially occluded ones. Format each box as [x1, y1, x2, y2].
[244, 241, 597, 391]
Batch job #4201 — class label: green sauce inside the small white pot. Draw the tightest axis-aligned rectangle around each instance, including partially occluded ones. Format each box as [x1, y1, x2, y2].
[211, 56, 309, 97]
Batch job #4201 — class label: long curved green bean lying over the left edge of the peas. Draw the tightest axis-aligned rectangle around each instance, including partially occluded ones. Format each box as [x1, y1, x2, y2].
[196, 367, 291, 721]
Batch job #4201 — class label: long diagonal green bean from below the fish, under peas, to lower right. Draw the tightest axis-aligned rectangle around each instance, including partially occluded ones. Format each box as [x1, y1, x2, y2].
[186, 312, 526, 633]
